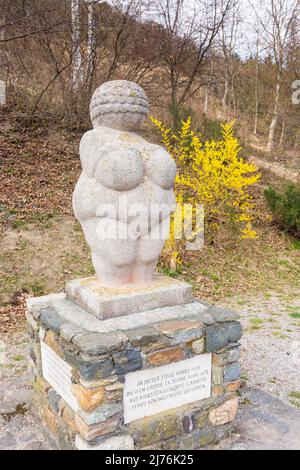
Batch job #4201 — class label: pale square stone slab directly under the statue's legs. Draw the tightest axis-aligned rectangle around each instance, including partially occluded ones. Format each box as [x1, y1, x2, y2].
[66, 274, 193, 320]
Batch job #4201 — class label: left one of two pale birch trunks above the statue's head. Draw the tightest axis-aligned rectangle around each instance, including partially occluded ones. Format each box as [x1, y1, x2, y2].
[71, 0, 83, 91]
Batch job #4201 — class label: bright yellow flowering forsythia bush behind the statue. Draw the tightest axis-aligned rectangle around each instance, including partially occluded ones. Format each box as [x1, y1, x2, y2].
[150, 117, 260, 264]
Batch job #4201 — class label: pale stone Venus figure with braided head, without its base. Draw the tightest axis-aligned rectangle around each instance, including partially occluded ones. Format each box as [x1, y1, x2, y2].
[73, 80, 176, 287]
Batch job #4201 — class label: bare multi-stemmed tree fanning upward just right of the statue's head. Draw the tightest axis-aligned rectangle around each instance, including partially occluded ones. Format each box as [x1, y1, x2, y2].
[154, 0, 233, 123]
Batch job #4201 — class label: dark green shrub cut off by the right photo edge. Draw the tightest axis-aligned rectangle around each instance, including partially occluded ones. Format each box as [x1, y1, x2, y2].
[265, 184, 300, 237]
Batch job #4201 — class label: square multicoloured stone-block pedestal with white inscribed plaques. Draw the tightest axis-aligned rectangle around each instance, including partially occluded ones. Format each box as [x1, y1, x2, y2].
[27, 288, 242, 450]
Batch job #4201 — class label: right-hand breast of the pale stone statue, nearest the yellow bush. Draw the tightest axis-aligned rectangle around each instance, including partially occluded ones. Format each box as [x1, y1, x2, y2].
[141, 145, 176, 189]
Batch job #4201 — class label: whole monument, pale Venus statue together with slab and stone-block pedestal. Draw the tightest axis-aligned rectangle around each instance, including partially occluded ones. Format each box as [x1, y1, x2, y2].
[26, 81, 242, 452]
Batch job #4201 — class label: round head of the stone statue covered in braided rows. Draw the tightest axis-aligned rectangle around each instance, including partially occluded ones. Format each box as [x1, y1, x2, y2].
[90, 80, 149, 131]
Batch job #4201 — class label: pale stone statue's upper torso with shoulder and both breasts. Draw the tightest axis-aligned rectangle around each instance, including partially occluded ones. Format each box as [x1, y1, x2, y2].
[80, 128, 176, 191]
